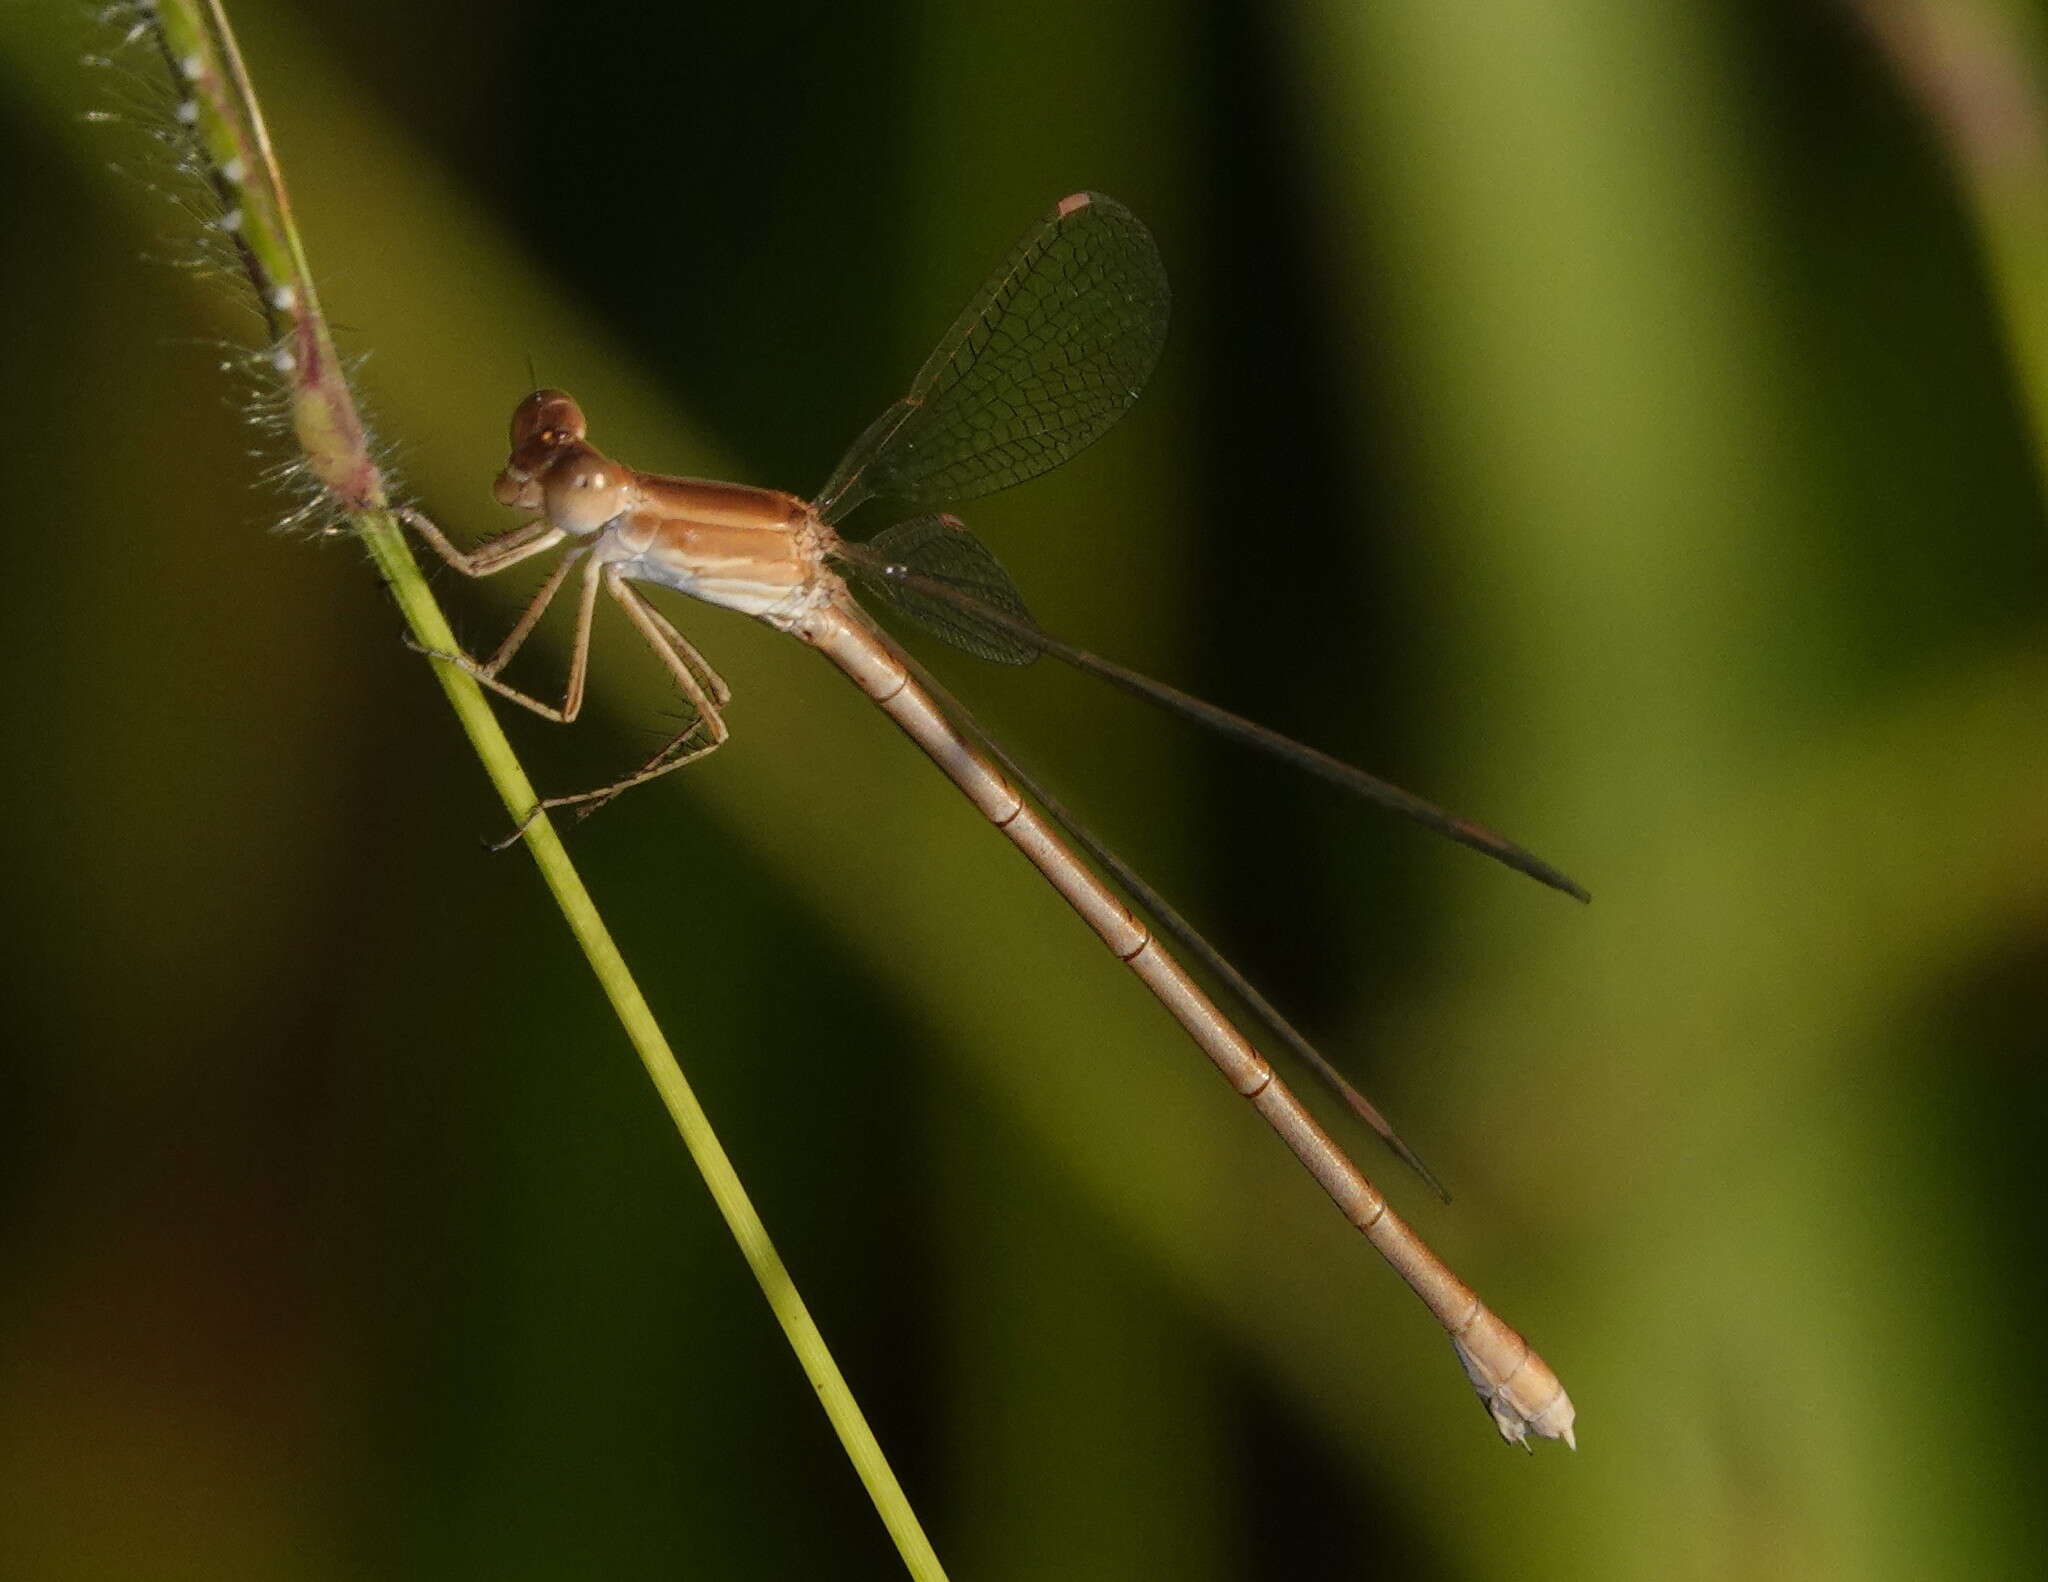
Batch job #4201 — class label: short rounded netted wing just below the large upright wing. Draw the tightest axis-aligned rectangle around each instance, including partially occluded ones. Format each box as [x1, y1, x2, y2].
[834, 516, 1038, 664]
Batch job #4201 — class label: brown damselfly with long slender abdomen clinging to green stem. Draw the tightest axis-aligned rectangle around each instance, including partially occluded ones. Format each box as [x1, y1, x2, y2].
[406, 193, 1585, 1443]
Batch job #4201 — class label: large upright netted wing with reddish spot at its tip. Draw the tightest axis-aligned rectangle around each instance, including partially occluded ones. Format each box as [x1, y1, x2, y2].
[817, 193, 1169, 523]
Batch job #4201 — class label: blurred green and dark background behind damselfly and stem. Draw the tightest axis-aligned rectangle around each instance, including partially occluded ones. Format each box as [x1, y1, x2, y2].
[0, 0, 2048, 1582]
